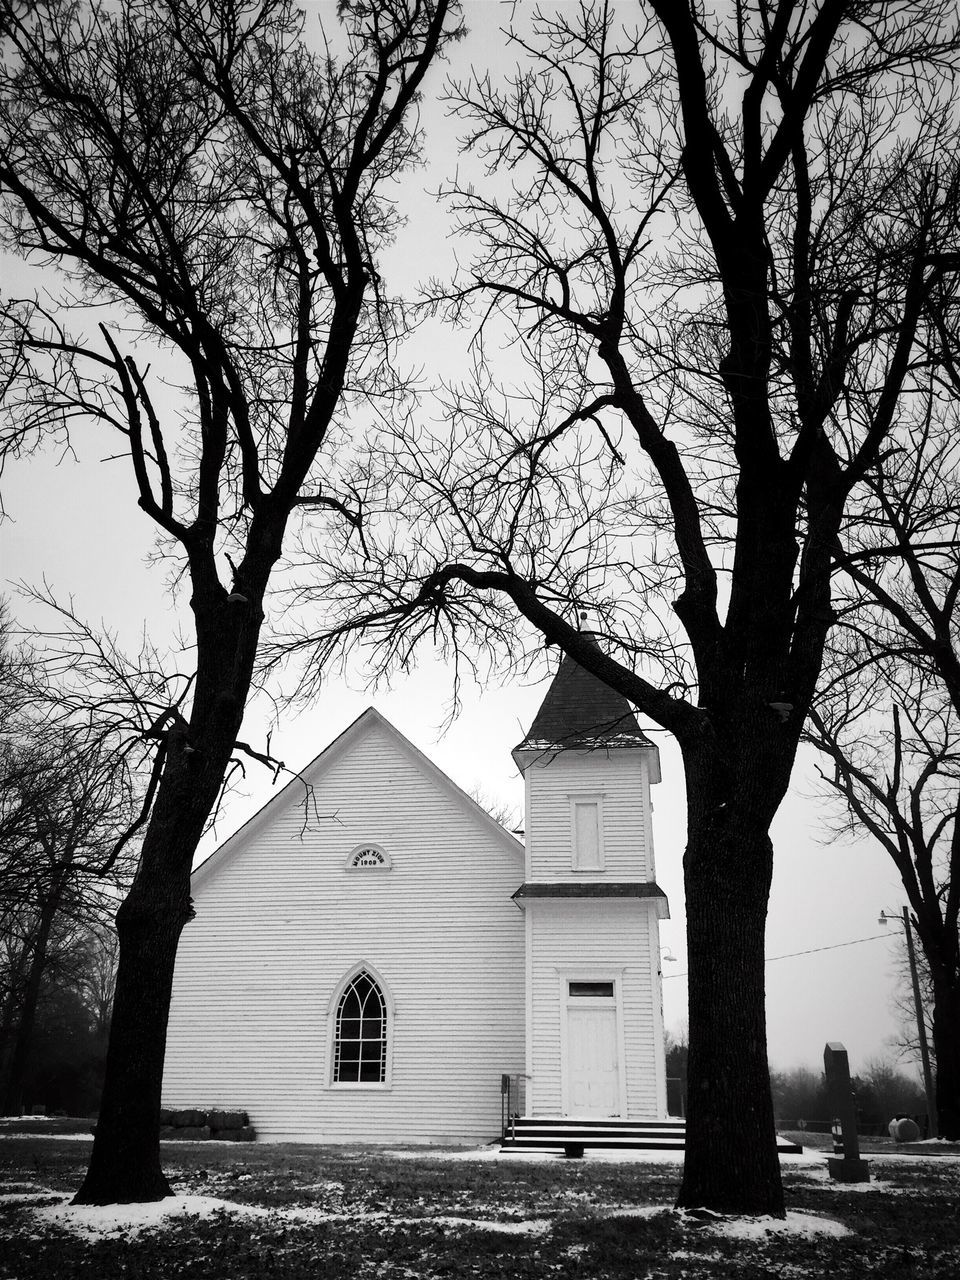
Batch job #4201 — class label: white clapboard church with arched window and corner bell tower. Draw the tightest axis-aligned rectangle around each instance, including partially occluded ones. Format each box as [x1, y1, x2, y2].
[164, 645, 667, 1143]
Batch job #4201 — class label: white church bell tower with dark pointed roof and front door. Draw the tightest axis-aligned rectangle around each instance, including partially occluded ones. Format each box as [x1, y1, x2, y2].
[513, 640, 669, 1120]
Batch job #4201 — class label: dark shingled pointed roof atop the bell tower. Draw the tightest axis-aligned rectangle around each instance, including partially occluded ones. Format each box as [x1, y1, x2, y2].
[515, 637, 654, 751]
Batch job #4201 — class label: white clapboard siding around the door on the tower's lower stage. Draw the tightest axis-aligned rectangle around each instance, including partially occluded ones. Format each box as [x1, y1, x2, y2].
[526, 899, 666, 1120]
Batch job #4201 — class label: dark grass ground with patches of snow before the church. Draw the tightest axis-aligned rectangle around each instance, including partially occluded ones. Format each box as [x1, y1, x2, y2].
[0, 1129, 960, 1280]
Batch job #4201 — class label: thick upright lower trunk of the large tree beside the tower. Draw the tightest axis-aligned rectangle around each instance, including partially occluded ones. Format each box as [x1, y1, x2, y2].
[677, 732, 785, 1217]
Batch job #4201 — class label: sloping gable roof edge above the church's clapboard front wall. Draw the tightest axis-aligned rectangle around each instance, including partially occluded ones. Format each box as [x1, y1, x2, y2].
[192, 707, 524, 884]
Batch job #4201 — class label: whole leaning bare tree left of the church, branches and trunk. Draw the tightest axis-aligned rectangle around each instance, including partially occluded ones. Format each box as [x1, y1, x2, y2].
[0, 0, 458, 1203]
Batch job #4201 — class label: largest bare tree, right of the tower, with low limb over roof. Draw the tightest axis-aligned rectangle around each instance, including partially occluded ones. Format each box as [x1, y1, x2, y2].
[291, 0, 960, 1215]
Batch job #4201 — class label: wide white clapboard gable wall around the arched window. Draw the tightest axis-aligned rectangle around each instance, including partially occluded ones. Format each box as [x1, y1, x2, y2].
[164, 710, 524, 1142]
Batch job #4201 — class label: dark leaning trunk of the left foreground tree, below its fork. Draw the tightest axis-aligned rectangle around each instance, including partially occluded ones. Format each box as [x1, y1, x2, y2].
[74, 586, 262, 1204]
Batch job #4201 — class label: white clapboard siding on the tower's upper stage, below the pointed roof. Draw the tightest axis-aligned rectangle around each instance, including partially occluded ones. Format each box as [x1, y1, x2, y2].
[526, 748, 653, 881]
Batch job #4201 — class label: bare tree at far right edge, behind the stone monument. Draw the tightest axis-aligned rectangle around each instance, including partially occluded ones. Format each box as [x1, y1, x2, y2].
[805, 404, 960, 1139]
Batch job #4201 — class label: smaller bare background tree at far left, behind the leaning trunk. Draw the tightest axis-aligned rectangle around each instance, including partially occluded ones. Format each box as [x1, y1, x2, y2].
[0, 593, 142, 1114]
